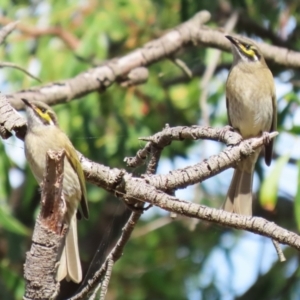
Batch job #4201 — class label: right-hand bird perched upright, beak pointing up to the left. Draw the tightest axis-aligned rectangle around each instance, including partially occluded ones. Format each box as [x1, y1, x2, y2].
[223, 36, 277, 215]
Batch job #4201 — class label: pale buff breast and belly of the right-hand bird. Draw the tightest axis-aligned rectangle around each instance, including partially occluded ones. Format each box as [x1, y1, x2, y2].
[226, 65, 275, 138]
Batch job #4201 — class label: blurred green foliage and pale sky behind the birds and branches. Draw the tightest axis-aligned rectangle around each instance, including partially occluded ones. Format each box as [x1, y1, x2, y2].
[0, 0, 300, 300]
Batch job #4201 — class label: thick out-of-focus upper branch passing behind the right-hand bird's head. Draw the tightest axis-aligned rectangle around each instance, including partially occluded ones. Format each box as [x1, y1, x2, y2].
[7, 11, 300, 109]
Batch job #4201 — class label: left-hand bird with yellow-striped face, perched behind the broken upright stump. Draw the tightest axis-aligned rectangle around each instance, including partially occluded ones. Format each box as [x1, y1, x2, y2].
[22, 99, 89, 283]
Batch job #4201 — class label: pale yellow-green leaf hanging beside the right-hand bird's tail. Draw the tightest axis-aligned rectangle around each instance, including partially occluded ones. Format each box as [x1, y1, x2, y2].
[259, 154, 290, 210]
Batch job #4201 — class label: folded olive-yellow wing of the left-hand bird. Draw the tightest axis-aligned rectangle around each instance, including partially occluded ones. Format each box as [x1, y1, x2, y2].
[65, 137, 89, 219]
